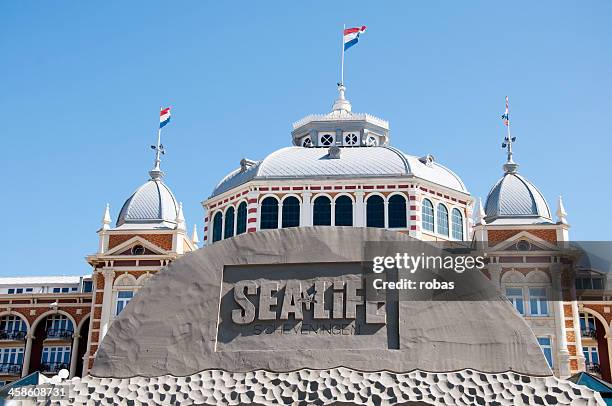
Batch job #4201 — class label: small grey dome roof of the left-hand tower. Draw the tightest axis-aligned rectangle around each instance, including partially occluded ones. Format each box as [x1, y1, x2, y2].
[117, 177, 178, 228]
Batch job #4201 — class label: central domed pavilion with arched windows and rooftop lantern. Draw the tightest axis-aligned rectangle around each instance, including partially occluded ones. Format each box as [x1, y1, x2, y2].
[202, 85, 474, 243]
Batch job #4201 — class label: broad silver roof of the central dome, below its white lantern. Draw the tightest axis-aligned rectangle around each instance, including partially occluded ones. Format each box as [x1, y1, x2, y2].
[211, 146, 468, 197]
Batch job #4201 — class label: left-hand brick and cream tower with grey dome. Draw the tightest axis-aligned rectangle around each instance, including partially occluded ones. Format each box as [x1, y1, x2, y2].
[84, 153, 198, 372]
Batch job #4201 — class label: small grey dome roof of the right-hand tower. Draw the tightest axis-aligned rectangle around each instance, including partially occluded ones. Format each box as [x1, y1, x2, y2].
[485, 171, 552, 223]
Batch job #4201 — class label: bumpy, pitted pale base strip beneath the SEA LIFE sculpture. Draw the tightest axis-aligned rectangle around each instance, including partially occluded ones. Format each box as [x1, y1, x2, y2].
[11, 367, 604, 406]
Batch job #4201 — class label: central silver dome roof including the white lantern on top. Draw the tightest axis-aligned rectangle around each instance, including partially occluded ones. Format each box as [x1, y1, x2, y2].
[210, 84, 468, 198]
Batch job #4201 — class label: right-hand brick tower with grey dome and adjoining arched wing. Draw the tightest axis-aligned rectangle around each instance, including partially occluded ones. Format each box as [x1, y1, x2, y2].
[473, 139, 612, 381]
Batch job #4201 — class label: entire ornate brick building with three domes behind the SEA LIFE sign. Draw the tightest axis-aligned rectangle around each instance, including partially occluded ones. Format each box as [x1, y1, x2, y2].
[0, 84, 612, 388]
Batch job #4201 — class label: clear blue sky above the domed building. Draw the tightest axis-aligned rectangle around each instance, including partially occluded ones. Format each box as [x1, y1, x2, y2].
[0, 1, 612, 276]
